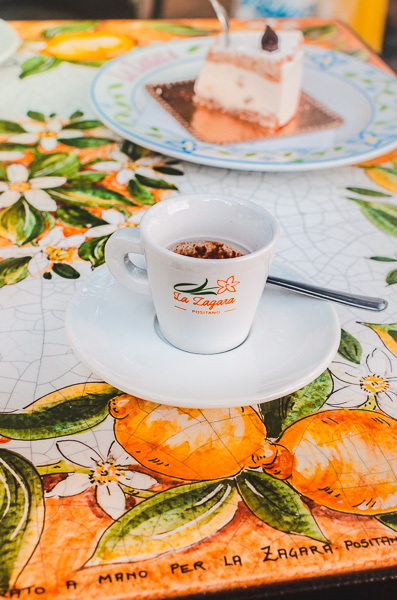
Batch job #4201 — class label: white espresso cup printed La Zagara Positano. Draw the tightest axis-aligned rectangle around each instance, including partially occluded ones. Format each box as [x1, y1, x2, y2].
[105, 193, 279, 354]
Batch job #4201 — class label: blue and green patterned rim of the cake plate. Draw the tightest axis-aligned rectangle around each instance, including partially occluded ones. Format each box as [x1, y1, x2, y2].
[90, 37, 397, 172]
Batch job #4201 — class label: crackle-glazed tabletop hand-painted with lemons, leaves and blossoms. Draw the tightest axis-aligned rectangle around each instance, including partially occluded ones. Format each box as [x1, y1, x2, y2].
[0, 20, 397, 600]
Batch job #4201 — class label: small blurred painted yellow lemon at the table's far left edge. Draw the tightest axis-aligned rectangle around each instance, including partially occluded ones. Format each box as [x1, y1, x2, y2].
[46, 31, 134, 61]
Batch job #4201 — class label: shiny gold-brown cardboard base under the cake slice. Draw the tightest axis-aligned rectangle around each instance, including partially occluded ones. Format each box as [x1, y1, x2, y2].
[146, 79, 343, 144]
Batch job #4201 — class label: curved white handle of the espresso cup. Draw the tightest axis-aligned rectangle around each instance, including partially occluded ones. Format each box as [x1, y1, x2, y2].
[105, 227, 150, 294]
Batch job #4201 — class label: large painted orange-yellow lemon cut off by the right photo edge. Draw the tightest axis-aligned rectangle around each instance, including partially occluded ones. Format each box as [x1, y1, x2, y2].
[257, 409, 397, 515]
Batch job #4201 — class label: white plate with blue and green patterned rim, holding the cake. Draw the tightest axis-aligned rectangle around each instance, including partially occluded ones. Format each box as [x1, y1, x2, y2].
[91, 38, 397, 171]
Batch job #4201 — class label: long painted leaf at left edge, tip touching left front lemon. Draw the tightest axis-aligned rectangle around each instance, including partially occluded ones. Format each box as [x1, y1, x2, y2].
[0, 383, 121, 440]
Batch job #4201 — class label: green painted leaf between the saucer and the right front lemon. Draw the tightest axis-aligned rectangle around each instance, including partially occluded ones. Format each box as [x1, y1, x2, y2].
[260, 370, 333, 438]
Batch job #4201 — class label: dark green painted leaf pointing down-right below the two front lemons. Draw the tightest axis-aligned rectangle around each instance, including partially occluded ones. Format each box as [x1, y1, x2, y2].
[236, 471, 328, 543]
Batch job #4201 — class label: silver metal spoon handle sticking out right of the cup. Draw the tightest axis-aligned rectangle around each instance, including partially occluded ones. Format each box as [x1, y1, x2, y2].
[267, 275, 387, 311]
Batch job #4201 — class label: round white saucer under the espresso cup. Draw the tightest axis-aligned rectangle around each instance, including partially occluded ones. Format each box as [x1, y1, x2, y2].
[66, 265, 340, 408]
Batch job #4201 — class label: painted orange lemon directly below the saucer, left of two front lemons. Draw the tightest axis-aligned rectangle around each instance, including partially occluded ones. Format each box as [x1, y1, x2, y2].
[109, 394, 266, 481]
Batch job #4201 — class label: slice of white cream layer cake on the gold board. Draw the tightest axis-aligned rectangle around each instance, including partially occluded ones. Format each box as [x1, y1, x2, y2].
[194, 30, 303, 127]
